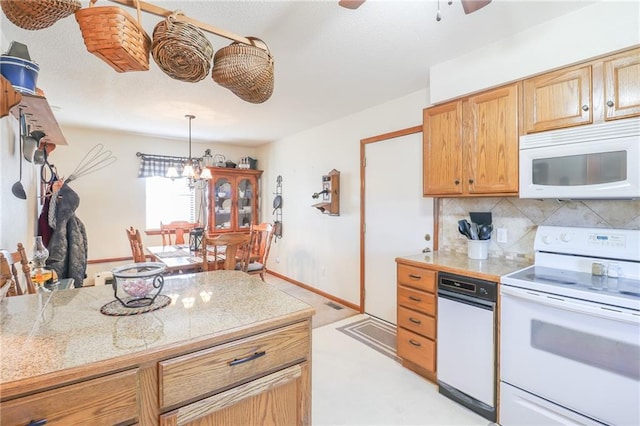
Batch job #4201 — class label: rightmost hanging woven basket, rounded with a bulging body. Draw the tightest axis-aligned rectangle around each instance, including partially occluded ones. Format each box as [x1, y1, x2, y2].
[211, 37, 274, 104]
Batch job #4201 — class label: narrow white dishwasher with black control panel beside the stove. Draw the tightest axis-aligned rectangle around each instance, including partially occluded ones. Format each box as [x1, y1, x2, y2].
[437, 272, 497, 422]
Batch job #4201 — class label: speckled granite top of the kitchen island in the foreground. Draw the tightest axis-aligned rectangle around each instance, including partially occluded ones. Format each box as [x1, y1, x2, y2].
[0, 271, 314, 385]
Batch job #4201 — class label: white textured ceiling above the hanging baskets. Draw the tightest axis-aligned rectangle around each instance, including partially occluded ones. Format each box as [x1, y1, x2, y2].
[0, 0, 594, 146]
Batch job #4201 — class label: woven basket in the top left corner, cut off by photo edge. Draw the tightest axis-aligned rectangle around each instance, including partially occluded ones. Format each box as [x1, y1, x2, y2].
[0, 0, 82, 30]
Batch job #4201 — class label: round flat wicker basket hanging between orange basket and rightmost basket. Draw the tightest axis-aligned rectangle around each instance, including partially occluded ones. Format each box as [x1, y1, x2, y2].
[151, 12, 213, 83]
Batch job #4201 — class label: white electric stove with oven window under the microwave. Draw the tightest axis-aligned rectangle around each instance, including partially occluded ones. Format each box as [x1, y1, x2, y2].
[499, 226, 640, 426]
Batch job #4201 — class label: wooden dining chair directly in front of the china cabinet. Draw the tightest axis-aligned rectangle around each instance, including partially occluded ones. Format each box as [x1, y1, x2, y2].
[202, 232, 251, 272]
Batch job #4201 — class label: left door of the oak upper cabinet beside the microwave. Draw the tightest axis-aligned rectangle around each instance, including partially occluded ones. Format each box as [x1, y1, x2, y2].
[422, 101, 463, 196]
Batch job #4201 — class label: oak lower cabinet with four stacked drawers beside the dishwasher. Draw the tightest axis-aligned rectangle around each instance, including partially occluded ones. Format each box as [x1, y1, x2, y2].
[396, 260, 437, 382]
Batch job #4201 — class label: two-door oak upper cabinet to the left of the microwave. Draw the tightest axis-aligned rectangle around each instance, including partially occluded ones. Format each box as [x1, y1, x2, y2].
[423, 83, 519, 196]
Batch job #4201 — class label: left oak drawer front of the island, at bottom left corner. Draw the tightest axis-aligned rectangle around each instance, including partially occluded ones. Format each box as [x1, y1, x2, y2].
[0, 369, 140, 425]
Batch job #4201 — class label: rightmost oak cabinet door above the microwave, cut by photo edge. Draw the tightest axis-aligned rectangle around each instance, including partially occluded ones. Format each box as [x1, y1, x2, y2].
[604, 49, 640, 120]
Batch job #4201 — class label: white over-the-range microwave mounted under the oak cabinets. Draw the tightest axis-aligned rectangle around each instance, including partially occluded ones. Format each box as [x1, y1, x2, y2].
[519, 118, 640, 200]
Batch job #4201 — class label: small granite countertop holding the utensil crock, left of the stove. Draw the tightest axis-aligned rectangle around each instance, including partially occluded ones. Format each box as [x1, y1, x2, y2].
[396, 251, 532, 282]
